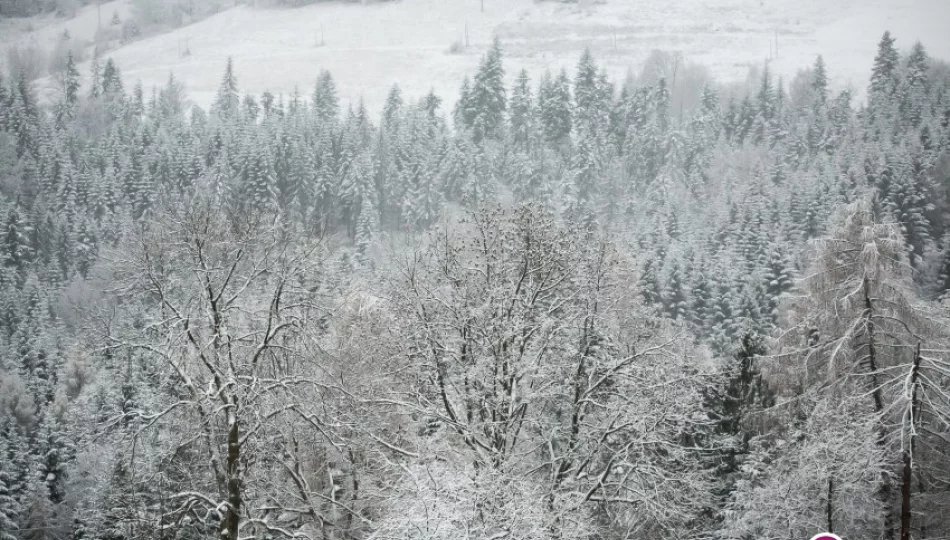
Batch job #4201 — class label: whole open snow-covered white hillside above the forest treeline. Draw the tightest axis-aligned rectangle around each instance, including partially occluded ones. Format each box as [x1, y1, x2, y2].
[0, 0, 950, 115]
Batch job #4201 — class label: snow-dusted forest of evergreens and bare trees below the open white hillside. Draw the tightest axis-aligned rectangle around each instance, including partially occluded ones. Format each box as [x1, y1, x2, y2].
[0, 3, 950, 540]
